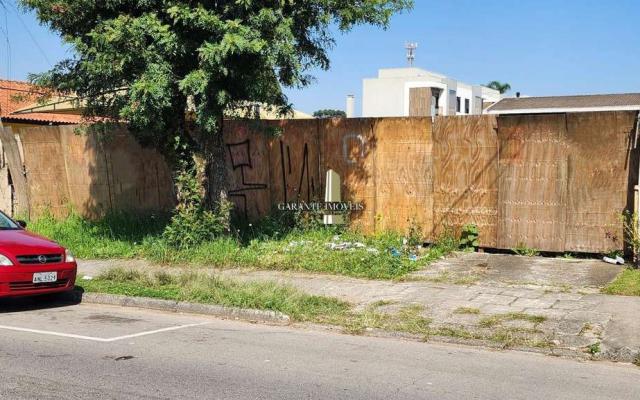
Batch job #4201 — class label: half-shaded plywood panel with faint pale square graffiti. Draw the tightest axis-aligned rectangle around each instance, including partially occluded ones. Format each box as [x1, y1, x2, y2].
[320, 118, 378, 233]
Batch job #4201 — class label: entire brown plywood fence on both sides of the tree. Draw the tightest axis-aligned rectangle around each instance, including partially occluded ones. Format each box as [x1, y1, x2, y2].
[0, 112, 638, 252]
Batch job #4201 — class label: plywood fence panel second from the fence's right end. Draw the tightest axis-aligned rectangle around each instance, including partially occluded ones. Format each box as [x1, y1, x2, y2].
[498, 114, 568, 251]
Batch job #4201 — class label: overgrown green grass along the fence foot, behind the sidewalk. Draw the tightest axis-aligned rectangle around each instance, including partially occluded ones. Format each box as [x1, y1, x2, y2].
[29, 213, 458, 283]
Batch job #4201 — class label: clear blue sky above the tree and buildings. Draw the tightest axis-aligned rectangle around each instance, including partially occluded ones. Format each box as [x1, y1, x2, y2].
[0, 0, 640, 113]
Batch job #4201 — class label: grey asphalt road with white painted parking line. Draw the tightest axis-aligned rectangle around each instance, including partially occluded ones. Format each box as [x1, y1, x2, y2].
[0, 301, 640, 400]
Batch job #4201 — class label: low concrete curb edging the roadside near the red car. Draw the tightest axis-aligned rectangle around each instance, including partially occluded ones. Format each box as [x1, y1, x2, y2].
[72, 292, 291, 325]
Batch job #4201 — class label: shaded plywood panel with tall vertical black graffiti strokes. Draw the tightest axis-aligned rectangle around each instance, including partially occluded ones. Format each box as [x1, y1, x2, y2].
[269, 119, 324, 204]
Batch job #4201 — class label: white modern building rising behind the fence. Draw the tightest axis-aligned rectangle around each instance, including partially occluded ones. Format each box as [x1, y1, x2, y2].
[362, 68, 501, 117]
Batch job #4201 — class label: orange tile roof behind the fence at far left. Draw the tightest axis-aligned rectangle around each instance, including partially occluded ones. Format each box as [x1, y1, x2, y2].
[0, 79, 82, 124]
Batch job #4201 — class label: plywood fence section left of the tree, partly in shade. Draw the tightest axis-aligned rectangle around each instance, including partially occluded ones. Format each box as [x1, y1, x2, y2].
[15, 126, 175, 218]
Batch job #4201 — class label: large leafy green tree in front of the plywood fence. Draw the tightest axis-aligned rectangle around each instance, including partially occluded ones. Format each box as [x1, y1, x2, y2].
[21, 0, 413, 227]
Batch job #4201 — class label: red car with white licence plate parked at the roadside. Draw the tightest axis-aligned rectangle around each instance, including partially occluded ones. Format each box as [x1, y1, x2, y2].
[0, 211, 78, 297]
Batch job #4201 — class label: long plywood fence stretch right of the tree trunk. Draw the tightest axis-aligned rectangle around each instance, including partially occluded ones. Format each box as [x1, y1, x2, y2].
[226, 112, 637, 252]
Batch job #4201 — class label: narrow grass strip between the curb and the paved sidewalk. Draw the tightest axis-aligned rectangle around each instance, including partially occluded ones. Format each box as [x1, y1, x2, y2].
[78, 268, 552, 347]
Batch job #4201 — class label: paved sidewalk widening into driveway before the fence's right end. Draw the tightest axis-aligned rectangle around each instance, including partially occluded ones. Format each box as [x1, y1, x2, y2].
[79, 253, 640, 362]
